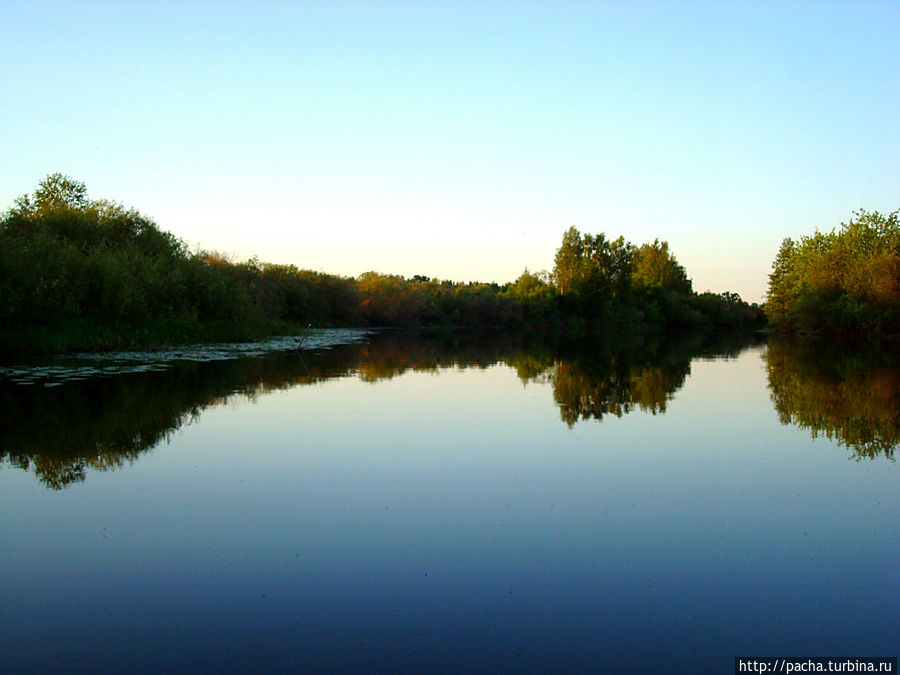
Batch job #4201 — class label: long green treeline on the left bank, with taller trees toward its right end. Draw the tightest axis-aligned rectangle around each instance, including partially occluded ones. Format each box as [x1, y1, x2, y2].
[0, 173, 764, 351]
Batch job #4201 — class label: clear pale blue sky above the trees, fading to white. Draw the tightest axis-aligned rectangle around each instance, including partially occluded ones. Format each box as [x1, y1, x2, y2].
[0, 0, 900, 301]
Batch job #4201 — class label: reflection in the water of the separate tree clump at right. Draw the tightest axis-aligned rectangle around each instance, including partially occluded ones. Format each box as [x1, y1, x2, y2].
[766, 342, 900, 460]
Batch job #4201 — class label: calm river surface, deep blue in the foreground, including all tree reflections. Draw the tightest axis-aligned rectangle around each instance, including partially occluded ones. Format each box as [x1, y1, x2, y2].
[0, 333, 900, 673]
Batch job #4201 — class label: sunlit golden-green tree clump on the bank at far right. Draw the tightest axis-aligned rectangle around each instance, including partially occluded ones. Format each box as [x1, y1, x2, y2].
[765, 211, 900, 340]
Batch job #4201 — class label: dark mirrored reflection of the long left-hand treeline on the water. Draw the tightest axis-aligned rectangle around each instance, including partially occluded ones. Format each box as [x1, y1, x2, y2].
[0, 331, 764, 490]
